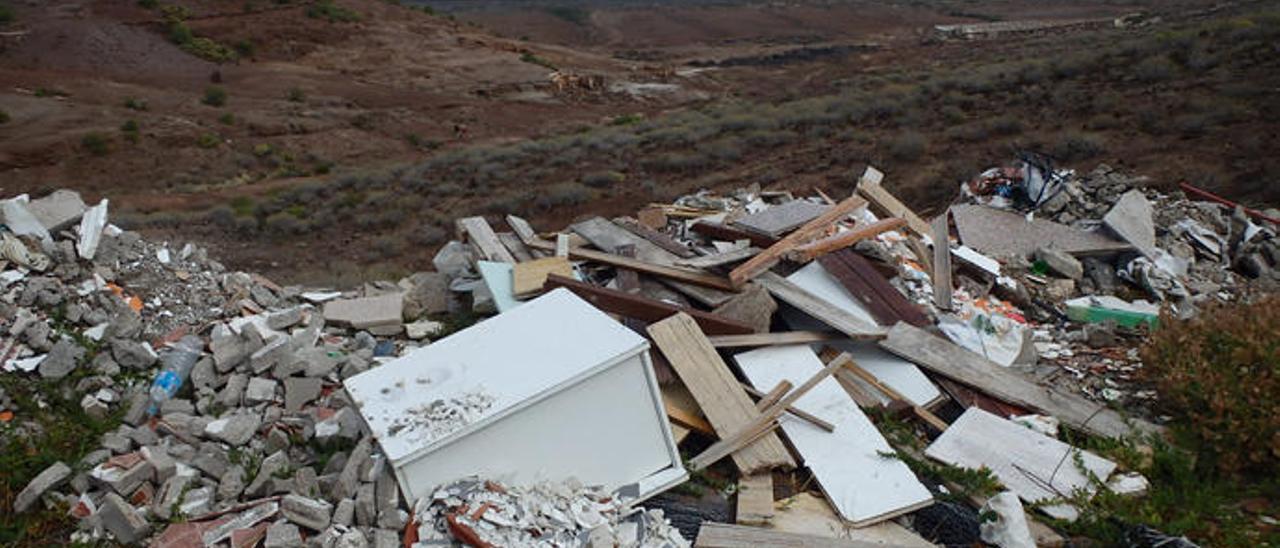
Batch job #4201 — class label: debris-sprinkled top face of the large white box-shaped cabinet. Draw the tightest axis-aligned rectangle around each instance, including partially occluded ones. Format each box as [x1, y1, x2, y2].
[344, 288, 658, 462]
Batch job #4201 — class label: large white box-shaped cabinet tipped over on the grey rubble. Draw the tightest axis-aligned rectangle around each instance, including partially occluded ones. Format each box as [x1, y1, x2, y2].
[344, 289, 684, 499]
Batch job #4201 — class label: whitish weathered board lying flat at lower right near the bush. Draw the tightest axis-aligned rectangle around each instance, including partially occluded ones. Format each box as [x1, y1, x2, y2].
[924, 407, 1116, 515]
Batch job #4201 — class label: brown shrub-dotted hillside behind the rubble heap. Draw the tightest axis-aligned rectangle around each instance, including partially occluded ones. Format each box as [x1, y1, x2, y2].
[0, 0, 1280, 282]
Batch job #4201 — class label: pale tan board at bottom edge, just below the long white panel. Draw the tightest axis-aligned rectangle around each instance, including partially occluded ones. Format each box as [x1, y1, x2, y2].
[771, 492, 933, 548]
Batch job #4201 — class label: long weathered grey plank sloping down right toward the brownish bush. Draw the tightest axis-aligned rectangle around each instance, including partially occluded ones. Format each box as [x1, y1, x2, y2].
[879, 323, 1164, 438]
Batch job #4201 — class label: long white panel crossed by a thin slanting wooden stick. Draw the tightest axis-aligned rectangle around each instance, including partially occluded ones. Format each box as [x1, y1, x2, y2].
[733, 344, 933, 526]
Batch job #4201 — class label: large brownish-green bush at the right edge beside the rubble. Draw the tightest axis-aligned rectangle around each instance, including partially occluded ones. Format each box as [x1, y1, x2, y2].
[1142, 296, 1280, 478]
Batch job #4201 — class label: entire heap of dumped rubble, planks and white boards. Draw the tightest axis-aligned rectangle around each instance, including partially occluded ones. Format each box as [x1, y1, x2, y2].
[0, 155, 1280, 548]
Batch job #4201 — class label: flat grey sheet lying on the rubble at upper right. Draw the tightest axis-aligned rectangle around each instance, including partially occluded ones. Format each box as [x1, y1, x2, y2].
[951, 204, 1133, 257]
